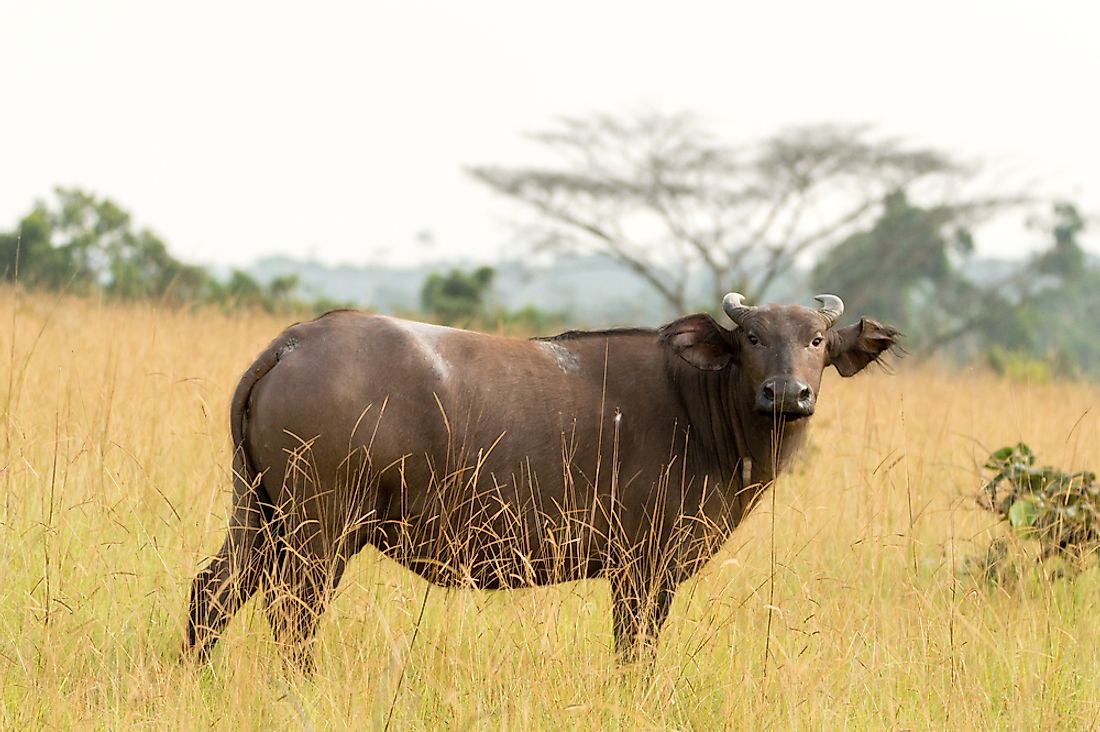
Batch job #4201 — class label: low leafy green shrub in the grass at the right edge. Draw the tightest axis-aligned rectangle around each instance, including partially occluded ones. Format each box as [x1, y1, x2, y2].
[979, 443, 1100, 559]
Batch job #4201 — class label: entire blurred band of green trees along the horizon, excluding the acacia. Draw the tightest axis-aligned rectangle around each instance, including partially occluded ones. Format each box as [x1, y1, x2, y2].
[0, 182, 1100, 380]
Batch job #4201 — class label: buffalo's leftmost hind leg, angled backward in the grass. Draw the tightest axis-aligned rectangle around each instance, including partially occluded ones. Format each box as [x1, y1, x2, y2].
[184, 481, 275, 662]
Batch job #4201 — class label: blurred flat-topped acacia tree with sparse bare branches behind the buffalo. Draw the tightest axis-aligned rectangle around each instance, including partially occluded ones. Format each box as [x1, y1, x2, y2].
[469, 112, 972, 312]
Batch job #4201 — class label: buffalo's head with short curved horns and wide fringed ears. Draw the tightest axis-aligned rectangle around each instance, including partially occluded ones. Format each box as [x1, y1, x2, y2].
[661, 293, 899, 419]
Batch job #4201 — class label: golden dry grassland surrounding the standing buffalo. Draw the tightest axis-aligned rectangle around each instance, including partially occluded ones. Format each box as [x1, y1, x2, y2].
[0, 289, 1100, 730]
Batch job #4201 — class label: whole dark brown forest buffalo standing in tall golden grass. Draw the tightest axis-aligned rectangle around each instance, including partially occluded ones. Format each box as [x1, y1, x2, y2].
[185, 293, 899, 668]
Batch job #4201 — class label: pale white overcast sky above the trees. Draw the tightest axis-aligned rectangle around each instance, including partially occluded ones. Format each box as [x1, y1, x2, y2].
[0, 0, 1100, 264]
